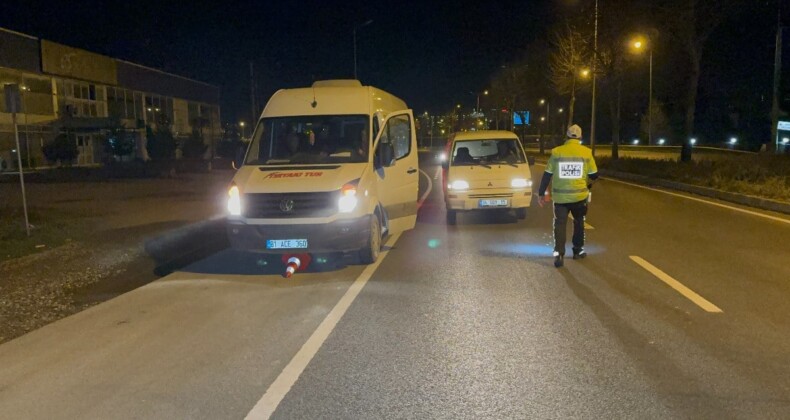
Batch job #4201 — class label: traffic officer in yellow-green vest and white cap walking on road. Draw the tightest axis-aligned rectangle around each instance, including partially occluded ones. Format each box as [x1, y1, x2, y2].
[538, 124, 598, 268]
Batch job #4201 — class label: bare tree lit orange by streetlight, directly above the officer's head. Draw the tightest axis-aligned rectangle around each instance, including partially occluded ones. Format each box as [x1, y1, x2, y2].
[549, 24, 591, 129]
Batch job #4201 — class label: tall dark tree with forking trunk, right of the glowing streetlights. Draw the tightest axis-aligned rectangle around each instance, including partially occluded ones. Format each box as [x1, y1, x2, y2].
[659, 0, 746, 162]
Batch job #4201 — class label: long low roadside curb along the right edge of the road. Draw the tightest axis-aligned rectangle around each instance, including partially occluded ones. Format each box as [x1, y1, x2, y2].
[600, 169, 790, 214]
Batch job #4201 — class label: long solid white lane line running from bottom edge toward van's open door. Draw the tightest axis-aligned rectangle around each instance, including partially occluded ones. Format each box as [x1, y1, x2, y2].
[245, 233, 400, 420]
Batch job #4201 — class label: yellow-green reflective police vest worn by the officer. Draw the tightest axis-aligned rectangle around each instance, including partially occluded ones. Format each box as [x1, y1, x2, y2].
[546, 139, 598, 204]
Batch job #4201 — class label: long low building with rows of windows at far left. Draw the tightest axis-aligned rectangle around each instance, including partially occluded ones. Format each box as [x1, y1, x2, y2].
[0, 28, 221, 170]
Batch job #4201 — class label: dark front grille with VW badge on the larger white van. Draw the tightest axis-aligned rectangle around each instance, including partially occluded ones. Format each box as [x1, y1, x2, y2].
[243, 191, 339, 219]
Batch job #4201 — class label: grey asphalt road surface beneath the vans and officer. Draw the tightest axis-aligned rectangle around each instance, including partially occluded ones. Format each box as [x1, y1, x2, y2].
[0, 154, 790, 419]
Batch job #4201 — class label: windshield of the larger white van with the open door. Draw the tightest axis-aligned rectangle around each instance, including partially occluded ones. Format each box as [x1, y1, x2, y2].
[245, 115, 371, 165]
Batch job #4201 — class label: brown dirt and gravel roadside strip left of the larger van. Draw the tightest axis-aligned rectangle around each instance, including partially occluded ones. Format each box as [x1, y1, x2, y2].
[0, 171, 233, 343]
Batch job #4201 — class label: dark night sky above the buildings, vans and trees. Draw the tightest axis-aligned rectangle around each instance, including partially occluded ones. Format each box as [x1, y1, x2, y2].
[0, 0, 775, 144]
